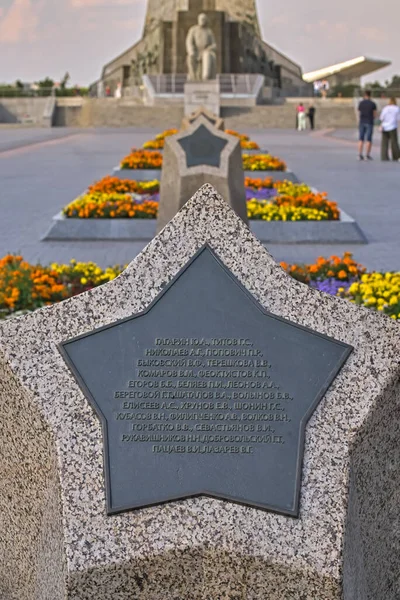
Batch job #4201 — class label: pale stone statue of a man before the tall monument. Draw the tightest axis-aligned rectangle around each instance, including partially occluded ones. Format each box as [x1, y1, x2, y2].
[186, 13, 217, 81]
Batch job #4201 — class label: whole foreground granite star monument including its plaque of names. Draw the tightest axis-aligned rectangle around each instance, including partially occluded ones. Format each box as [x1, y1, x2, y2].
[0, 185, 400, 600]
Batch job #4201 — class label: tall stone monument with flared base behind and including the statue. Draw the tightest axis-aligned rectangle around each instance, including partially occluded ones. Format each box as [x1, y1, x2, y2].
[97, 0, 308, 95]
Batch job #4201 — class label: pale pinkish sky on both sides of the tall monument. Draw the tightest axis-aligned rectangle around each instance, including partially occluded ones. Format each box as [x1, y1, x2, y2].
[0, 0, 400, 85]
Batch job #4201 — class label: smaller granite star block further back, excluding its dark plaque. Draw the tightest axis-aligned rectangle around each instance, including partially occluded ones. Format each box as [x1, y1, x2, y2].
[157, 115, 248, 232]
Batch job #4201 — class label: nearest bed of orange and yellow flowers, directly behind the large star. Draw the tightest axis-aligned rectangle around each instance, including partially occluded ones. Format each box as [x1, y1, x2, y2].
[0, 252, 400, 320]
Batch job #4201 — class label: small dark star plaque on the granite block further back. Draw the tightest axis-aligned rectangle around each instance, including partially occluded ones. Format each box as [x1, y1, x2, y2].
[178, 125, 228, 168]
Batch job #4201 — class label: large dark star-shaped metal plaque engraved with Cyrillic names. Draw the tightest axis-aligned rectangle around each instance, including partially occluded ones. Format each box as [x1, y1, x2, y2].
[60, 246, 352, 516]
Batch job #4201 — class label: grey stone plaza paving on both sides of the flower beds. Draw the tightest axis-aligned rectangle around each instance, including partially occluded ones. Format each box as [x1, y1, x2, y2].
[0, 123, 400, 270]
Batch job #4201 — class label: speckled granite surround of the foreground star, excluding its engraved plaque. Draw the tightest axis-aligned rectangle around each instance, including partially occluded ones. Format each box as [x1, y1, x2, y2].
[0, 186, 400, 600]
